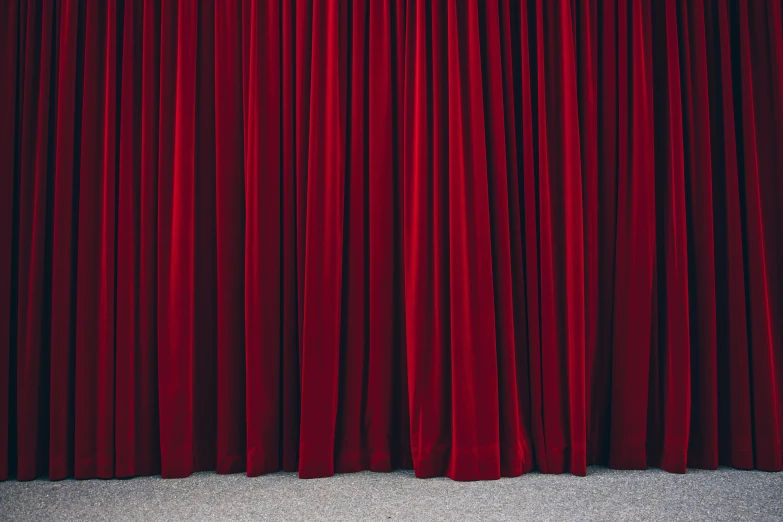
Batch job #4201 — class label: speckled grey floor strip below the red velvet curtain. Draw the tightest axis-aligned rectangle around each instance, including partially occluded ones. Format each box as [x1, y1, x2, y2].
[0, 467, 783, 521]
